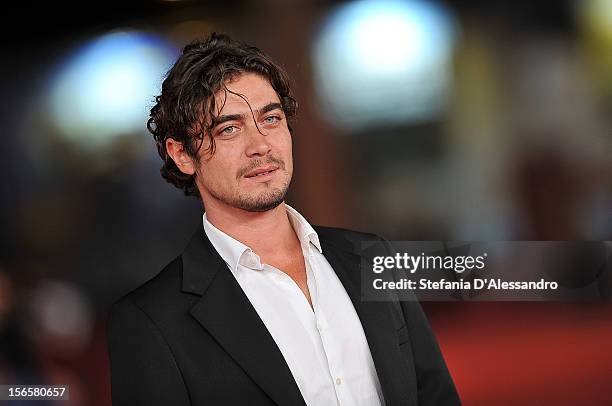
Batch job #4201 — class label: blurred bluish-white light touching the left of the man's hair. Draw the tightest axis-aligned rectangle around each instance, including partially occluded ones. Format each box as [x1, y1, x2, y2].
[49, 31, 176, 146]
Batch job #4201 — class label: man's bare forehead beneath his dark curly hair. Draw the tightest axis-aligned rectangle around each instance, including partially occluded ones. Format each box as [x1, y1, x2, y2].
[215, 73, 280, 115]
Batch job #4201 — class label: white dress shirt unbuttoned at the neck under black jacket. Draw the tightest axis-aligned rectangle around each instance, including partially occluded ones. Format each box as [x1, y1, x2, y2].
[203, 205, 384, 406]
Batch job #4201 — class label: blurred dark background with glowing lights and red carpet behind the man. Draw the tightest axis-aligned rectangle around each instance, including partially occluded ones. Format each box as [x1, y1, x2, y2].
[0, 0, 612, 405]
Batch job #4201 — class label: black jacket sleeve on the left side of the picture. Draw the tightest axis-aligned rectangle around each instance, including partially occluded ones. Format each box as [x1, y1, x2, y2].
[108, 298, 191, 406]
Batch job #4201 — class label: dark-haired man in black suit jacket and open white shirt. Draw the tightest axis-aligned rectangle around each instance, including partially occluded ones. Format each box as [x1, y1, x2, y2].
[108, 34, 459, 406]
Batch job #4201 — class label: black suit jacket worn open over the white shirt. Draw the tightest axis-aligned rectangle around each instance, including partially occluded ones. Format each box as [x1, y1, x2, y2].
[108, 227, 460, 406]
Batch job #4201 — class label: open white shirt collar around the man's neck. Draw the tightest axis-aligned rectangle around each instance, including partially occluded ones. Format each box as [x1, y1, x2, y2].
[202, 204, 323, 271]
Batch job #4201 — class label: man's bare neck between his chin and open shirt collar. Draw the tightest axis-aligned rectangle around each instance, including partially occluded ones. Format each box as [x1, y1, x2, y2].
[206, 203, 299, 257]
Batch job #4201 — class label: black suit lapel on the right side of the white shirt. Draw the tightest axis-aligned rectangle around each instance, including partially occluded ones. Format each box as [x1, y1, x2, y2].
[317, 230, 416, 406]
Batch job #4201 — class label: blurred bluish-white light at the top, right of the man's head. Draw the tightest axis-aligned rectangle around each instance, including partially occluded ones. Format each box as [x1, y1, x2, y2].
[313, 0, 457, 129]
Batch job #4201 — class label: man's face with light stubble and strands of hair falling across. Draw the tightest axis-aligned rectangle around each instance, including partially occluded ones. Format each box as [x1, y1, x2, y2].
[195, 73, 293, 212]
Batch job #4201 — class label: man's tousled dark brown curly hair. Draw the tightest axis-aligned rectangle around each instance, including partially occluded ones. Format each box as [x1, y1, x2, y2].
[147, 33, 297, 198]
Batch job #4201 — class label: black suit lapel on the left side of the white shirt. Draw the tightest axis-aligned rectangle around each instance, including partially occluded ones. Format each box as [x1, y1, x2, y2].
[183, 227, 304, 406]
